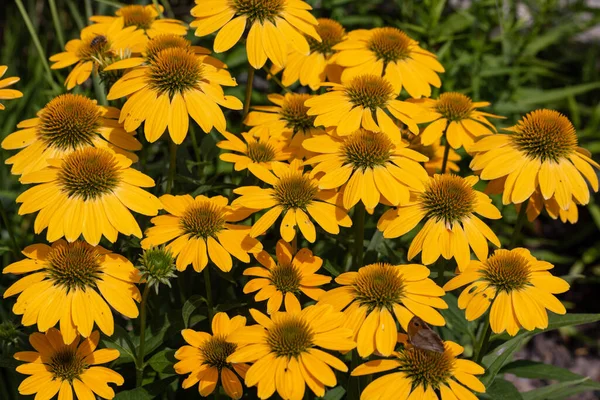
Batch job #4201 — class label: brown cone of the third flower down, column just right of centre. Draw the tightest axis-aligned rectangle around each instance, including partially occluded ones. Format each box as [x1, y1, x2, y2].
[341, 129, 394, 171]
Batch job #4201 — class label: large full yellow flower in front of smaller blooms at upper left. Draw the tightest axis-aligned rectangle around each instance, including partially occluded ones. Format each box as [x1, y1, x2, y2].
[107, 46, 243, 144]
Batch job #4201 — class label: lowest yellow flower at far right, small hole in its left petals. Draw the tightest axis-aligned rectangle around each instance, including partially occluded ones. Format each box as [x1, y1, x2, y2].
[444, 248, 569, 336]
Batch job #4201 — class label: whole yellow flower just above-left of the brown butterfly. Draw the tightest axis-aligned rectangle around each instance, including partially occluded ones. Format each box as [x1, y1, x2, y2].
[319, 263, 448, 357]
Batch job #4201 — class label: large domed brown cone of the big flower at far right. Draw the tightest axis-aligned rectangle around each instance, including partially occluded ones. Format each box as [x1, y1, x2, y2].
[513, 110, 577, 162]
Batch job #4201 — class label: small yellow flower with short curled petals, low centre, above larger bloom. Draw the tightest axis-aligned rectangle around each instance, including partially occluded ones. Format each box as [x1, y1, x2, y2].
[244, 240, 331, 314]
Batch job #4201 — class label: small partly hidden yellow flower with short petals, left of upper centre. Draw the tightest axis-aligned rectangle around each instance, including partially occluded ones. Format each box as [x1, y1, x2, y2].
[217, 132, 290, 171]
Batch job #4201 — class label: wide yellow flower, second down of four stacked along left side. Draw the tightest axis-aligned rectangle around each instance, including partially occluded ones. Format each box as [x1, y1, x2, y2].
[17, 147, 162, 245]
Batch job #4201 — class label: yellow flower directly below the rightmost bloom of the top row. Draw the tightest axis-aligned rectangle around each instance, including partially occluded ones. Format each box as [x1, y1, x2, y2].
[304, 74, 423, 142]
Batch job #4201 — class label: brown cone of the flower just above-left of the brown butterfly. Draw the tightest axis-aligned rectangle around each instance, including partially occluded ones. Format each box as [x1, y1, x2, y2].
[352, 263, 404, 311]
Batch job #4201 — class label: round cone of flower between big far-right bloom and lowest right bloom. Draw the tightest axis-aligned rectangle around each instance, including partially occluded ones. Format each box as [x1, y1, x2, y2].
[420, 175, 476, 224]
